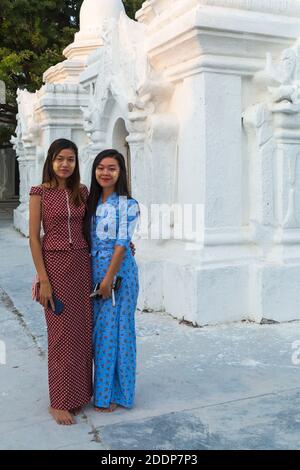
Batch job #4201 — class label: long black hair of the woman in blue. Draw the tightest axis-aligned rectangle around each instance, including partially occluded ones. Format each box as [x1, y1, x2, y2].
[83, 149, 131, 245]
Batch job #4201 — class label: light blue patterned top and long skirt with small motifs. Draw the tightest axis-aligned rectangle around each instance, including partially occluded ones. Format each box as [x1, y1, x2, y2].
[91, 193, 139, 408]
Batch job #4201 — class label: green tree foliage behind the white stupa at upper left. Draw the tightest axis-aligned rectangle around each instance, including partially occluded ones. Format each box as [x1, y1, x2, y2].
[0, 0, 143, 146]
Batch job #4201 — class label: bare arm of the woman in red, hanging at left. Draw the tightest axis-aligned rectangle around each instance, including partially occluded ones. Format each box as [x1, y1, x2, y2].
[29, 195, 55, 310]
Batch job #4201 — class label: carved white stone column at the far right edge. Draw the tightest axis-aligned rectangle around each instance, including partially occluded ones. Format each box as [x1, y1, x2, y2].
[244, 27, 300, 321]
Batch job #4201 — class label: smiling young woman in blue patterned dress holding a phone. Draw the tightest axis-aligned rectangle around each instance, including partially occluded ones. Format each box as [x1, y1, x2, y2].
[85, 150, 139, 412]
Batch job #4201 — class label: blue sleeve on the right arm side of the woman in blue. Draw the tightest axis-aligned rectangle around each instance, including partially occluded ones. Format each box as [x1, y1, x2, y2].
[116, 196, 140, 248]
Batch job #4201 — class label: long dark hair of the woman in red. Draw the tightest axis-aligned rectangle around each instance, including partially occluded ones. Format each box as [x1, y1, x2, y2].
[42, 139, 83, 206]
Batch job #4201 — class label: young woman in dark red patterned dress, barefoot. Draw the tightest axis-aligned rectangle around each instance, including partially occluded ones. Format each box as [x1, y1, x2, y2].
[29, 139, 92, 425]
